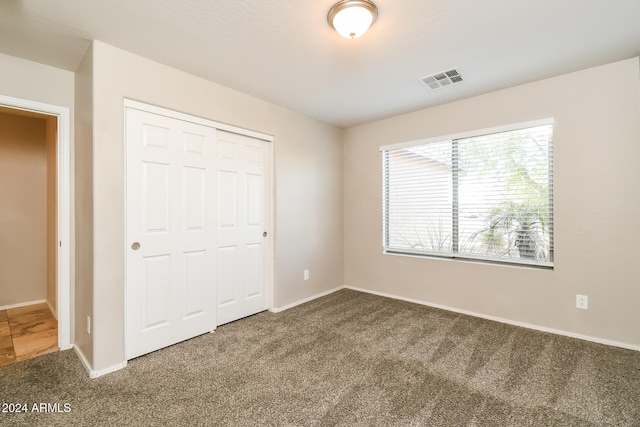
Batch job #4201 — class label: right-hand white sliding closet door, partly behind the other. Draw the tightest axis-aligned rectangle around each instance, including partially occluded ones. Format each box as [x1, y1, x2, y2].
[217, 131, 270, 325]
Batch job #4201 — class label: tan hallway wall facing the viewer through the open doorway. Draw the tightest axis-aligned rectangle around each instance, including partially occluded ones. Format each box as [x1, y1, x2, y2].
[0, 112, 47, 307]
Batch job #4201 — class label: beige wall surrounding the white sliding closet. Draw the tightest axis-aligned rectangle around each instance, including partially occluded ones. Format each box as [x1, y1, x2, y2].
[82, 42, 343, 371]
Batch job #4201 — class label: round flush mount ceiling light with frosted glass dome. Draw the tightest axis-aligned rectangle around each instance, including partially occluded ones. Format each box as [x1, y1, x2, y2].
[327, 0, 378, 39]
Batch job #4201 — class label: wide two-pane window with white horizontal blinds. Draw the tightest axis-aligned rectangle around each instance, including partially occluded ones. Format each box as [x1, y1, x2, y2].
[381, 120, 553, 267]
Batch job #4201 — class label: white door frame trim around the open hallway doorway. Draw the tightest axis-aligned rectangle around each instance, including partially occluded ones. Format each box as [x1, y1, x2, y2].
[0, 95, 73, 350]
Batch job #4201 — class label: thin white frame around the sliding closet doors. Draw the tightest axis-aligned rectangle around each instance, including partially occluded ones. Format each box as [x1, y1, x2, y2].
[123, 98, 275, 332]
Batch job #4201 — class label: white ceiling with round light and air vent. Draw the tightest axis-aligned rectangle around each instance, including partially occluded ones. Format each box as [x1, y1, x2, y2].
[0, 0, 640, 127]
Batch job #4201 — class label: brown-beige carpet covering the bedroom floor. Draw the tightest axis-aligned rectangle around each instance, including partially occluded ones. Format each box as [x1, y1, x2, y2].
[0, 290, 640, 427]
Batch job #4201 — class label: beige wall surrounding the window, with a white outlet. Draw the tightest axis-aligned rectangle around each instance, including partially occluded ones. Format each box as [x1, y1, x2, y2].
[344, 58, 640, 346]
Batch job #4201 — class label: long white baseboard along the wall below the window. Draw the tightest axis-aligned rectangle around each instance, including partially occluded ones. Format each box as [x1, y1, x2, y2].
[344, 286, 640, 351]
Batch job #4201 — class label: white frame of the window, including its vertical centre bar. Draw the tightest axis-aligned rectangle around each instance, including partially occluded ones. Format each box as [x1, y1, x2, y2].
[380, 118, 555, 269]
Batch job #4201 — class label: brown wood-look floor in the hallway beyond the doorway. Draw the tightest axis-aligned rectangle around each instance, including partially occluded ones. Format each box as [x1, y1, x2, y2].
[0, 303, 58, 366]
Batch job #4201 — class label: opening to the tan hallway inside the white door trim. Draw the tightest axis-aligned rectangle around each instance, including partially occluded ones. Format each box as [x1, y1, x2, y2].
[0, 107, 58, 365]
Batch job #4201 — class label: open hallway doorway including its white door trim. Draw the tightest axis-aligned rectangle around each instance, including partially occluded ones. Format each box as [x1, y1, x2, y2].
[0, 96, 71, 365]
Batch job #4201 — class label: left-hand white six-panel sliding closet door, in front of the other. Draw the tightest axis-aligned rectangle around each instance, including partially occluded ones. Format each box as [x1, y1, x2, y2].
[125, 108, 218, 359]
